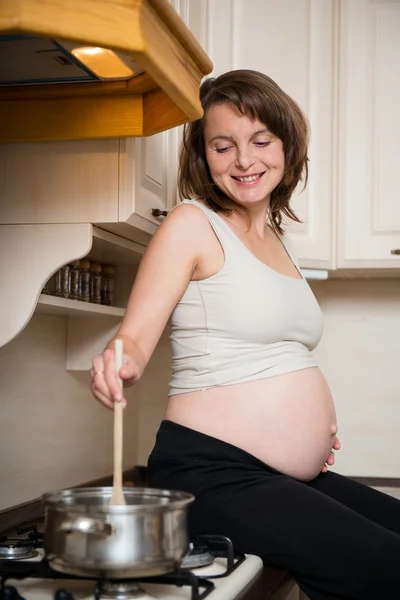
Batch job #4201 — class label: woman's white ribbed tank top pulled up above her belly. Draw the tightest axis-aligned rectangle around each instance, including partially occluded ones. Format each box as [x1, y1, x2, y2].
[169, 200, 322, 396]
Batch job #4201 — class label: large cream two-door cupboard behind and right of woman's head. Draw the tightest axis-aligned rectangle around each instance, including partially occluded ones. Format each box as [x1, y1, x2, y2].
[182, 0, 400, 270]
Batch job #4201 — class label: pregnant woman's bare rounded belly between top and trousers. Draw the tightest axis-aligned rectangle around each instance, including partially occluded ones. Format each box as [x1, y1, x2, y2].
[165, 367, 336, 481]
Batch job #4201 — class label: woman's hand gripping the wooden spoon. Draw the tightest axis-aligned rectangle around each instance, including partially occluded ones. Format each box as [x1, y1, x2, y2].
[90, 348, 141, 409]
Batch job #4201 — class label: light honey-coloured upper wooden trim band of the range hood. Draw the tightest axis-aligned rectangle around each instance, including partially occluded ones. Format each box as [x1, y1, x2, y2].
[0, 0, 213, 73]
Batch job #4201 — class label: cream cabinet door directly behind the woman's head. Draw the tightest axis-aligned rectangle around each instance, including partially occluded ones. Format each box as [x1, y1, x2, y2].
[197, 0, 336, 268]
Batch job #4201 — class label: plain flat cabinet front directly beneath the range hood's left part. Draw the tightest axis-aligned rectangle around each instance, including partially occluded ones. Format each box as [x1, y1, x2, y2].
[0, 139, 119, 225]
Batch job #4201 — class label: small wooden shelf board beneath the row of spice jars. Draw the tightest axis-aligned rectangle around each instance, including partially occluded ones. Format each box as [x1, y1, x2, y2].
[35, 294, 125, 319]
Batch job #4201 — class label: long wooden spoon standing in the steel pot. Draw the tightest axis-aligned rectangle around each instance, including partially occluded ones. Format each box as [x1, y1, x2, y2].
[110, 339, 126, 506]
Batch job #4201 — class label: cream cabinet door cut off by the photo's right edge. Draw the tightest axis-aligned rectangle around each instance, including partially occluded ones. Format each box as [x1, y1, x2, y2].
[338, 0, 400, 268]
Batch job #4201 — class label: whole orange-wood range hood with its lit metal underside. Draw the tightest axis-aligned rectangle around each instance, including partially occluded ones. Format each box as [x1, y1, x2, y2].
[0, 0, 212, 142]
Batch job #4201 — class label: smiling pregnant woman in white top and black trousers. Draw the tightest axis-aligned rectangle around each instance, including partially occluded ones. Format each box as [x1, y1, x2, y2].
[91, 71, 400, 600]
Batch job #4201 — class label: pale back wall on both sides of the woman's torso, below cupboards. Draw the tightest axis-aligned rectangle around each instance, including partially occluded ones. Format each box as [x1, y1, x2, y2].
[138, 280, 400, 477]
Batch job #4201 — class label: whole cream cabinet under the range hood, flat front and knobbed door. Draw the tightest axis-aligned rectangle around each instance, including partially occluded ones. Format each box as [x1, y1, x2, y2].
[0, 133, 164, 244]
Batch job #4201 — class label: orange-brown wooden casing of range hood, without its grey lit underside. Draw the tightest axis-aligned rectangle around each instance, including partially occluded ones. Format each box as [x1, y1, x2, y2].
[0, 0, 213, 142]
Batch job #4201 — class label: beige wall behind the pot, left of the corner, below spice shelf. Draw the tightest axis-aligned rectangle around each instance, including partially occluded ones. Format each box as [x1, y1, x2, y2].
[0, 315, 138, 510]
